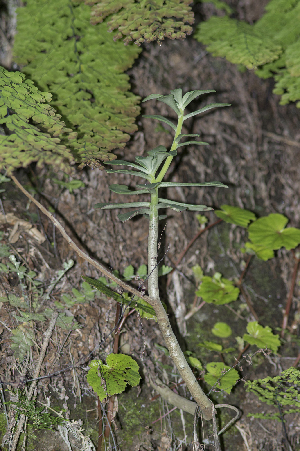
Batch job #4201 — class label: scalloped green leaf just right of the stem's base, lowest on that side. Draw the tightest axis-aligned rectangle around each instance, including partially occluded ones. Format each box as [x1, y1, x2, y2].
[204, 362, 240, 393]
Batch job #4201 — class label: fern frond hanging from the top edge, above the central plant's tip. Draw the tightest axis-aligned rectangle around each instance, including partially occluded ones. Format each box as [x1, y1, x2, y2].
[86, 0, 194, 46]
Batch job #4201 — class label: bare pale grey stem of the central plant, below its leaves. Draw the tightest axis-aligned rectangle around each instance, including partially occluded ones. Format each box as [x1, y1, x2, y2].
[148, 188, 213, 420]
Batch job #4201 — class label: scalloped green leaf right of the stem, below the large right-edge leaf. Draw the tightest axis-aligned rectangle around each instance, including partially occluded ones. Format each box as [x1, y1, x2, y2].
[196, 272, 240, 305]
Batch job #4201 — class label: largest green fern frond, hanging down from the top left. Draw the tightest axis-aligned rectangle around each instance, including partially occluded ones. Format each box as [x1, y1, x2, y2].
[11, 0, 141, 167]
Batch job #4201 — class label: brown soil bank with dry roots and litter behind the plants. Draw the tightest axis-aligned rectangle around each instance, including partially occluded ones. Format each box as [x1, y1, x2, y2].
[0, 2, 300, 451]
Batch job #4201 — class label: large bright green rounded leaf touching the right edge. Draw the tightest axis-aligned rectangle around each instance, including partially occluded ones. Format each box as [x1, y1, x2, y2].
[248, 214, 300, 250]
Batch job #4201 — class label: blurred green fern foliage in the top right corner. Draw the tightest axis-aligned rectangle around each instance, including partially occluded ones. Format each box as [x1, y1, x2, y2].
[194, 0, 300, 108]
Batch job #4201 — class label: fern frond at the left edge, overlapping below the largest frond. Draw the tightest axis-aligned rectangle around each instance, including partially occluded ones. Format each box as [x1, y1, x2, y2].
[0, 67, 76, 175]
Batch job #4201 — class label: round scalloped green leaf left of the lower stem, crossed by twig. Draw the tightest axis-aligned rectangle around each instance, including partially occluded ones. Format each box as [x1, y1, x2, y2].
[87, 354, 141, 401]
